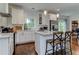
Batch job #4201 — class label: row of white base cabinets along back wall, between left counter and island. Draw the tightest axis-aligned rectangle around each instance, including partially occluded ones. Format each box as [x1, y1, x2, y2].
[15, 30, 35, 44]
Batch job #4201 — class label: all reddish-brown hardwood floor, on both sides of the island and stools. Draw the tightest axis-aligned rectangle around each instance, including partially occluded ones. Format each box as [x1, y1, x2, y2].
[15, 37, 79, 55]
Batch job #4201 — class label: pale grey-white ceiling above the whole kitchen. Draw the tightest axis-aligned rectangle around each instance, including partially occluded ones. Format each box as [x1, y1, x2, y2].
[11, 3, 79, 16]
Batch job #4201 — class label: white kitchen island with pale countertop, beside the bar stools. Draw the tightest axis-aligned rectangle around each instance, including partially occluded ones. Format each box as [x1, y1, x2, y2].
[35, 31, 53, 55]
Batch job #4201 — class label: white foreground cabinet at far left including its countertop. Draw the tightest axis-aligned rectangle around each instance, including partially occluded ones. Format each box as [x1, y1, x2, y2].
[0, 33, 14, 55]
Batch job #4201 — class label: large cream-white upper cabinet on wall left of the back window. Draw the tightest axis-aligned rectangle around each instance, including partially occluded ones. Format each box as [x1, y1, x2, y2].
[11, 7, 24, 24]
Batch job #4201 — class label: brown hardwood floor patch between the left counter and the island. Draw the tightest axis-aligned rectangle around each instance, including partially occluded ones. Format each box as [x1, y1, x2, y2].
[15, 42, 36, 55]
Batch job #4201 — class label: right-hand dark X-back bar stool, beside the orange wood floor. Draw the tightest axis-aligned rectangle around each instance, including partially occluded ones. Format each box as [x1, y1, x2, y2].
[65, 31, 72, 55]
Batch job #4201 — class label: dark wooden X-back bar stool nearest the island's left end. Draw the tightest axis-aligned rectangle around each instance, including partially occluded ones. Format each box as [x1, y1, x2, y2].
[45, 32, 63, 55]
